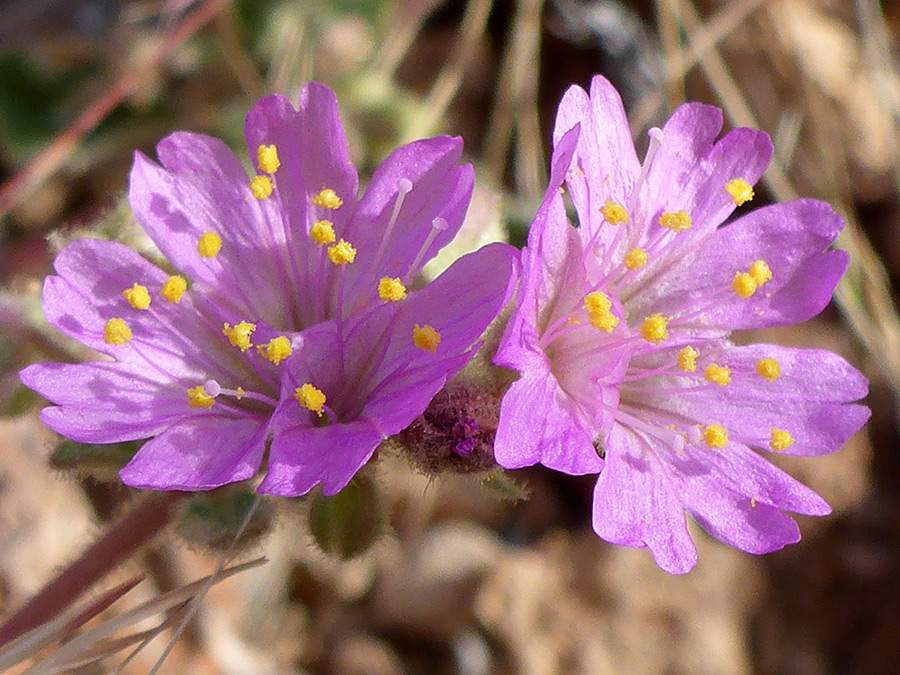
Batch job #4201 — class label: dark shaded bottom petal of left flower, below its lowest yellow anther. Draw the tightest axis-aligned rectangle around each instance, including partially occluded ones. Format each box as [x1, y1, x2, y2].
[257, 422, 381, 497]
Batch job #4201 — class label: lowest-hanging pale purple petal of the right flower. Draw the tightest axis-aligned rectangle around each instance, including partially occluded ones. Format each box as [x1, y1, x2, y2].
[593, 424, 697, 574]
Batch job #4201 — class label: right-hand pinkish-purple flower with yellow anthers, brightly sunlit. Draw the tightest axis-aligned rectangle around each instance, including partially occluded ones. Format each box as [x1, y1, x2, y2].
[495, 77, 869, 573]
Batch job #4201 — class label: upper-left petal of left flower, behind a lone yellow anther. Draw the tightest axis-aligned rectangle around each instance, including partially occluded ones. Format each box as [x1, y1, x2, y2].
[129, 133, 289, 324]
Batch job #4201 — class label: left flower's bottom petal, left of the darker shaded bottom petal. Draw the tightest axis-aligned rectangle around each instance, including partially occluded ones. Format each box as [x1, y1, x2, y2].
[119, 415, 266, 490]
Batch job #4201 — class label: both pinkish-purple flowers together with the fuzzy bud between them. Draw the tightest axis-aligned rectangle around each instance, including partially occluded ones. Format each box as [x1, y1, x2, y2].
[21, 77, 869, 573]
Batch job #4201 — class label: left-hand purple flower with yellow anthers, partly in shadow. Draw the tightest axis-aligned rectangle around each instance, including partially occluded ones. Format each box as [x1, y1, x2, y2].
[21, 84, 515, 495]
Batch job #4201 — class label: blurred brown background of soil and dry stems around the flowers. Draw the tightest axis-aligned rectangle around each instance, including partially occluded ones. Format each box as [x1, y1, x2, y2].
[0, 0, 900, 675]
